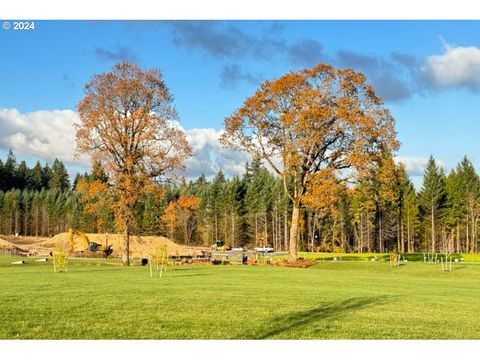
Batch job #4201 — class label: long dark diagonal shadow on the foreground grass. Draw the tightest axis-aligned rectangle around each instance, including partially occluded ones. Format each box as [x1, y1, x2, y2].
[245, 296, 390, 340]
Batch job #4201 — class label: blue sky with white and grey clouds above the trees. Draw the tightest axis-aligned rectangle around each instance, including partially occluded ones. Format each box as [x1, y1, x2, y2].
[0, 20, 480, 184]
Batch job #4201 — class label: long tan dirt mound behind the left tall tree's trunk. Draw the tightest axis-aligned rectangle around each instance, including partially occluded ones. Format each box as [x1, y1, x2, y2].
[36, 233, 201, 258]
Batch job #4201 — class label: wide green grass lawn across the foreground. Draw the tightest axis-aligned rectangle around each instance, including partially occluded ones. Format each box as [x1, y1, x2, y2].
[0, 257, 480, 340]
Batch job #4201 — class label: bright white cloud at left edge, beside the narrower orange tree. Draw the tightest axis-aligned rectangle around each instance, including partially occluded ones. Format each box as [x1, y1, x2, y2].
[0, 108, 89, 165]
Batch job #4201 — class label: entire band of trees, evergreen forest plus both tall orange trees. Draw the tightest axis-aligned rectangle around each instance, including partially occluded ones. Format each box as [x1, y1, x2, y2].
[0, 62, 478, 258]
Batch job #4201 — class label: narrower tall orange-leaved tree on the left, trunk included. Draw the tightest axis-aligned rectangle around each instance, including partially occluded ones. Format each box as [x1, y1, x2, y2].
[76, 62, 191, 265]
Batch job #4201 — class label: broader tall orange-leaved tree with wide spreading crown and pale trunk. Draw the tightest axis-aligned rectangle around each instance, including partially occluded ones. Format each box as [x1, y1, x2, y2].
[222, 64, 398, 261]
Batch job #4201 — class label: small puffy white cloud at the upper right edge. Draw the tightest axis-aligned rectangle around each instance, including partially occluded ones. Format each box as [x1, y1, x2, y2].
[421, 44, 480, 91]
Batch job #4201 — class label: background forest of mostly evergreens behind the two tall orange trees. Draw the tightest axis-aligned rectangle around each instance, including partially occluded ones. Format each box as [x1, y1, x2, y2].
[0, 148, 480, 253]
